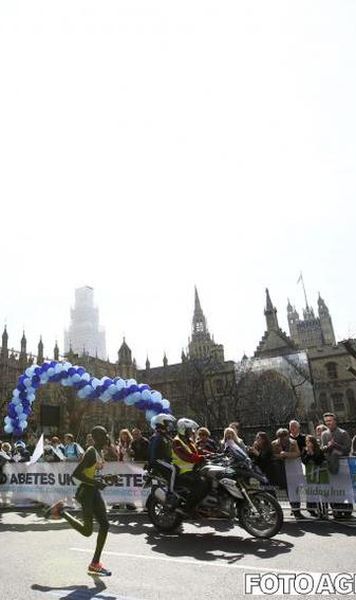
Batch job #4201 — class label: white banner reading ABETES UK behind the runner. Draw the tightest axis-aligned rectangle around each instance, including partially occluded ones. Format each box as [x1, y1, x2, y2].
[0, 462, 149, 506]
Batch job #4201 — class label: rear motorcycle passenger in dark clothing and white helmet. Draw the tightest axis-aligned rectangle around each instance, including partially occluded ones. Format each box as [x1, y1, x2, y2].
[148, 413, 176, 496]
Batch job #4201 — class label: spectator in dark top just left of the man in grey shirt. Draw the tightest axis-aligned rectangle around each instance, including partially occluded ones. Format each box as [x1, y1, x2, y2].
[301, 435, 328, 519]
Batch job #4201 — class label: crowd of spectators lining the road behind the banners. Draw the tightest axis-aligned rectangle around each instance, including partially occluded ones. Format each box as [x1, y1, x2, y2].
[0, 413, 356, 518]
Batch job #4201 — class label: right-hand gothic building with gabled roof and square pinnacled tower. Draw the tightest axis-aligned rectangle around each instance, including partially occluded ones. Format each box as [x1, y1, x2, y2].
[250, 290, 356, 423]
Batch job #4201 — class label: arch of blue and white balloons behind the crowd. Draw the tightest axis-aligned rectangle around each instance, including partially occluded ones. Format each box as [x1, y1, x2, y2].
[4, 361, 171, 435]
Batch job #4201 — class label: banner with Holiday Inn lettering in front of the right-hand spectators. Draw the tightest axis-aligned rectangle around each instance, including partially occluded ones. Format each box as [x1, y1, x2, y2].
[285, 458, 356, 504]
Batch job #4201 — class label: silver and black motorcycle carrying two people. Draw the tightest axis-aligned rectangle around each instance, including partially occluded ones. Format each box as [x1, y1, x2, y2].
[144, 451, 283, 538]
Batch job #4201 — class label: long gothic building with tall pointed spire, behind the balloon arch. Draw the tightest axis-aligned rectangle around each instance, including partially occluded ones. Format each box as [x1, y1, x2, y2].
[0, 289, 235, 435]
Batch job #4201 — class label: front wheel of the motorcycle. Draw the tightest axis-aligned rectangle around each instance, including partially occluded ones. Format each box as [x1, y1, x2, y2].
[239, 492, 283, 538]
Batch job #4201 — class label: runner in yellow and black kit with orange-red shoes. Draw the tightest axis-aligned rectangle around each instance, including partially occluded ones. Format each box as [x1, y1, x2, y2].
[45, 425, 111, 576]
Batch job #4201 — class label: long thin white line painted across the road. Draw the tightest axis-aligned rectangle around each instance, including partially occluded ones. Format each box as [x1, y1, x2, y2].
[70, 548, 306, 575]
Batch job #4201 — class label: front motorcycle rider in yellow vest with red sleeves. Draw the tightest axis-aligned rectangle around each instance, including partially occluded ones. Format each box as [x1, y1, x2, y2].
[172, 418, 209, 513]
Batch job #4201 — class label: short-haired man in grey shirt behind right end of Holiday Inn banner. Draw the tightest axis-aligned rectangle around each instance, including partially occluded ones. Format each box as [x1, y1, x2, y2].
[321, 413, 353, 519]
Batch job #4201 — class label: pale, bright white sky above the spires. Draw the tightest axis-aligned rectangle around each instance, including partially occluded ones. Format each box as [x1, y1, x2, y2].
[0, 0, 356, 366]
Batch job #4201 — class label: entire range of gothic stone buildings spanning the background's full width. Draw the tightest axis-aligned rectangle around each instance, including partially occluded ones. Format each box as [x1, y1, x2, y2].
[0, 288, 356, 439]
